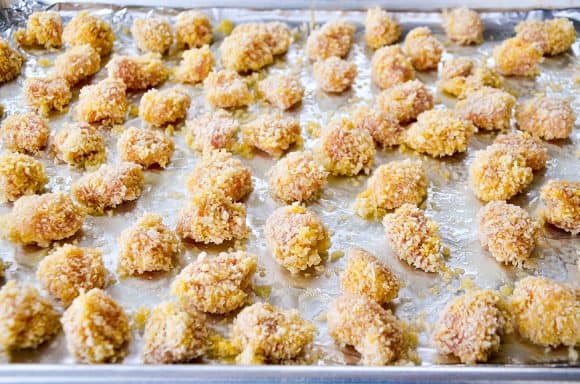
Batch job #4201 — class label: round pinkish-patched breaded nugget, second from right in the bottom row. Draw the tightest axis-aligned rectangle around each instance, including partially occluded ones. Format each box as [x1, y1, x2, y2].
[433, 290, 512, 364]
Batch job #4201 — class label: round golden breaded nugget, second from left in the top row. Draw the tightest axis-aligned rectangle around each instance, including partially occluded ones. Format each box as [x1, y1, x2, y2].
[62, 11, 115, 56]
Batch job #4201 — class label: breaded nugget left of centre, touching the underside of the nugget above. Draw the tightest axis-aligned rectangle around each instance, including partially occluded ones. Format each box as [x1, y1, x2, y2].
[176, 188, 250, 244]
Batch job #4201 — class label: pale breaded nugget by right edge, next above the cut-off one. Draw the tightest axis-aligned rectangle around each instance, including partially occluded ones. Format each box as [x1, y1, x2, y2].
[516, 96, 576, 140]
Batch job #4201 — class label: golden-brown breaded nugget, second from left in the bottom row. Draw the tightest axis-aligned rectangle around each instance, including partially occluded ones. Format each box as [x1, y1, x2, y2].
[60, 288, 131, 364]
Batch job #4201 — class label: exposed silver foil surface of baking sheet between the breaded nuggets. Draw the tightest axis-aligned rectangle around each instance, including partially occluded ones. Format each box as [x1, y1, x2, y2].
[0, 2, 580, 366]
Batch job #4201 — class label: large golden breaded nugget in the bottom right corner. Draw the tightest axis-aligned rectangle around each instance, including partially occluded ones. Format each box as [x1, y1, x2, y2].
[509, 276, 580, 347]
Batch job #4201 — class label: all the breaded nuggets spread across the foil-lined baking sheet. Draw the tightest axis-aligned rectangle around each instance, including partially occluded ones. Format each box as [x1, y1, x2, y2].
[0, 8, 580, 365]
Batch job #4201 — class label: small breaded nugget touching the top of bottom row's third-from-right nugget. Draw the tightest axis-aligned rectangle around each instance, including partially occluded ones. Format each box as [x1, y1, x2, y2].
[340, 248, 401, 304]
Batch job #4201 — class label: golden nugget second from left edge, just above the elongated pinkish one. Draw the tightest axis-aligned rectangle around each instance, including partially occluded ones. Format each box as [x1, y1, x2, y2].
[51, 123, 107, 168]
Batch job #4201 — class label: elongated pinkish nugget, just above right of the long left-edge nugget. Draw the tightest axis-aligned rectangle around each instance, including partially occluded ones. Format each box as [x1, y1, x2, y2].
[71, 163, 144, 213]
